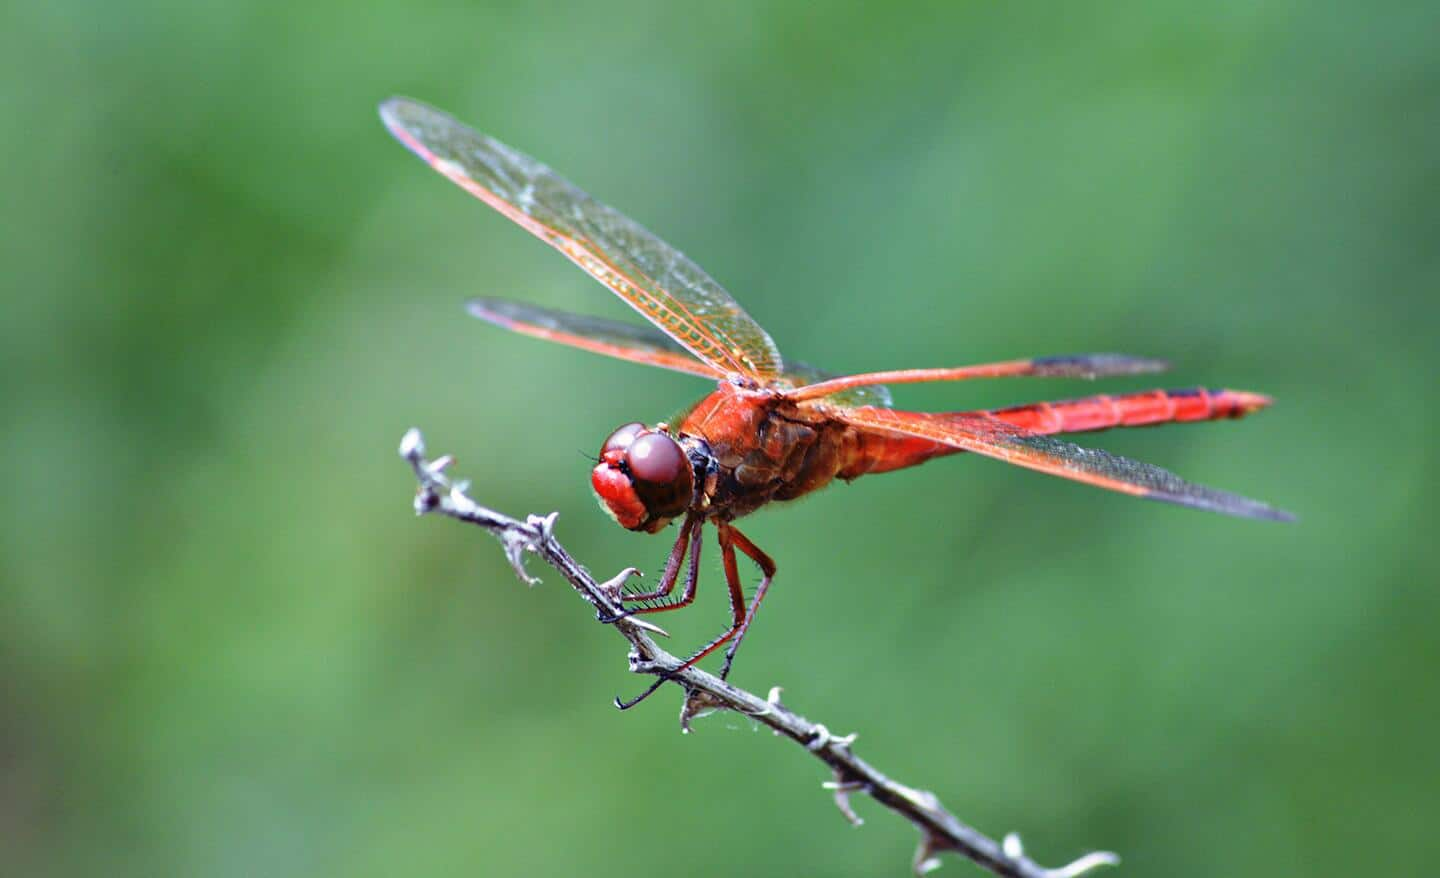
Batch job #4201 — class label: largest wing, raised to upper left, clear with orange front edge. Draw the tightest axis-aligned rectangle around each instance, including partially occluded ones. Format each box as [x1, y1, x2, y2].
[380, 98, 783, 381]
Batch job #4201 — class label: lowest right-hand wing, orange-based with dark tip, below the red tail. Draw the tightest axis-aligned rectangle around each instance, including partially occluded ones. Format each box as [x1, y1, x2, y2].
[829, 406, 1295, 521]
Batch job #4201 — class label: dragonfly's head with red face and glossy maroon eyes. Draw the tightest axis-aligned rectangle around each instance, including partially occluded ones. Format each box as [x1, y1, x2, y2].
[590, 423, 696, 534]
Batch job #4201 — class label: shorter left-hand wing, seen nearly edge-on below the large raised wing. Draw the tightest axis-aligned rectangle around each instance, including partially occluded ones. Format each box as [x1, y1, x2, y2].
[465, 298, 724, 379]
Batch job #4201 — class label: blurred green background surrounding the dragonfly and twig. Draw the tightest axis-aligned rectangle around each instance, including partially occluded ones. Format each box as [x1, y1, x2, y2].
[0, 0, 1440, 878]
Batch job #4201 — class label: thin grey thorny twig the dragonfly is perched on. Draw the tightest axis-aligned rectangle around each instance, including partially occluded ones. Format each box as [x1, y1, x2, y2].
[400, 429, 1120, 878]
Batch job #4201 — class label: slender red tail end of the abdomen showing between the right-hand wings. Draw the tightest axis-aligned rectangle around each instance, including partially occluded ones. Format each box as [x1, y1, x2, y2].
[988, 387, 1270, 433]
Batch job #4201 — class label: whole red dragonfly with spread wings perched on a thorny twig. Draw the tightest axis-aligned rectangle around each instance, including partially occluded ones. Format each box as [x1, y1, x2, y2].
[380, 98, 1293, 708]
